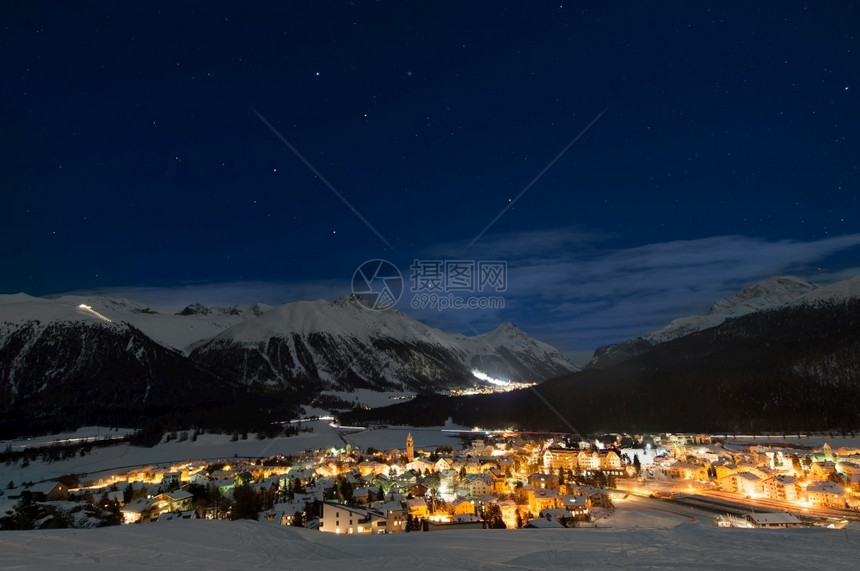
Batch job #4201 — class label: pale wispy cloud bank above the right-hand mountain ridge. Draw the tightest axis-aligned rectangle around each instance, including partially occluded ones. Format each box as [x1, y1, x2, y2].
[488, 230, 860, 348]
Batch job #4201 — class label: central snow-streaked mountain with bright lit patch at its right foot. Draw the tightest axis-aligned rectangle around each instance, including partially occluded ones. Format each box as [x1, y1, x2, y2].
[190, 296, 576, 391]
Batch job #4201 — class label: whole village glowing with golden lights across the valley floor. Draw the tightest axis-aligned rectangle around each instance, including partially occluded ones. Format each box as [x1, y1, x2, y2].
[5, 432, 860, 534]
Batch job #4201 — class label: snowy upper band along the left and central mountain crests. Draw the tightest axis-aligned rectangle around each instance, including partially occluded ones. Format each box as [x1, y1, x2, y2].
[0, 293, 577, 380]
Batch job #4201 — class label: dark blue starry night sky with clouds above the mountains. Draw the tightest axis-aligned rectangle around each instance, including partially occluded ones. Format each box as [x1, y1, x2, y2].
[0, 1, 860, 351]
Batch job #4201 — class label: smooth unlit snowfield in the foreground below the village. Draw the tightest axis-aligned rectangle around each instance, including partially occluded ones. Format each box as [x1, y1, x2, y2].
[0, 520, 860, 571]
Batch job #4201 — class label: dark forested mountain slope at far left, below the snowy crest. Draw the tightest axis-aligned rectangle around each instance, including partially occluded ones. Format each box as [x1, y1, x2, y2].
[0, 318, 244, 438]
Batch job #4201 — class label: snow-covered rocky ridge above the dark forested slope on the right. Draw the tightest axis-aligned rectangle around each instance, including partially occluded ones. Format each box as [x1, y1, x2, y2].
[589, 276, 860, 368]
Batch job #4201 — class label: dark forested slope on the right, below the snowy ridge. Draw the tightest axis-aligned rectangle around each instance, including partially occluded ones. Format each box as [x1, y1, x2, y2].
[364, 297, 860, 434]
